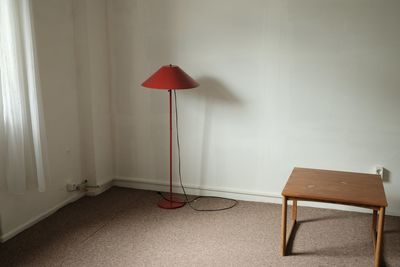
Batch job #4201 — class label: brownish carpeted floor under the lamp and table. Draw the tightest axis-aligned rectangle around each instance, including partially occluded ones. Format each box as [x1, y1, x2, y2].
[0, 188, 400, 267]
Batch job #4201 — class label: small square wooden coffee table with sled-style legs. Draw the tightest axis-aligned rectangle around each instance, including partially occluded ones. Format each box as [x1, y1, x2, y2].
[281, 167, 387, 266]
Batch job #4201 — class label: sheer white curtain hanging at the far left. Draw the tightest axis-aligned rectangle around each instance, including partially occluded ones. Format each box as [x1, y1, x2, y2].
[0, 0, 48, 193]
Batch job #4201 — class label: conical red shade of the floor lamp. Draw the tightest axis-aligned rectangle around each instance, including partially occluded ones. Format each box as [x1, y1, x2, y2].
[142, 65, 199, 90]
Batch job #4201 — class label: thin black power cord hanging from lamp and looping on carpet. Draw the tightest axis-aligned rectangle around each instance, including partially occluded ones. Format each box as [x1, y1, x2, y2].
[159, 90, 238, 211]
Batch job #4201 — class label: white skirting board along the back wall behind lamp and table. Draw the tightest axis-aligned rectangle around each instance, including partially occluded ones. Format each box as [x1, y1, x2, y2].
[113, 177, 400, 219]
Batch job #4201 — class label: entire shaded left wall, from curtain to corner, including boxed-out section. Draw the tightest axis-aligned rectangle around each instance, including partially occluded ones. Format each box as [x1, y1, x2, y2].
[0, 0, 114, 240]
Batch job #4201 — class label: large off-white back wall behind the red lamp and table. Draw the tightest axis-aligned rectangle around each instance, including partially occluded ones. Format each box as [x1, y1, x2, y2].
[109, 0, 400, 214]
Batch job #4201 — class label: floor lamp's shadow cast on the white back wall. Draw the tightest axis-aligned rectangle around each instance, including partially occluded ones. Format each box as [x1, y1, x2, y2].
[194, 77, 243, 191]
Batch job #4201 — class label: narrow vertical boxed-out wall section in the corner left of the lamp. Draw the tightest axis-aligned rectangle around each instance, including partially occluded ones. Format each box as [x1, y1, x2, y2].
[73, 0, 114, 188]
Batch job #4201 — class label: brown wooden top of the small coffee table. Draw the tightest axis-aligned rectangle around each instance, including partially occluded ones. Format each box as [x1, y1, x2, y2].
[282, 167, 387, 207]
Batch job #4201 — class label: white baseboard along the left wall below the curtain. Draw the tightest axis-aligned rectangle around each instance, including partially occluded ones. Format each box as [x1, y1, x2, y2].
[0, 192, 85, 243]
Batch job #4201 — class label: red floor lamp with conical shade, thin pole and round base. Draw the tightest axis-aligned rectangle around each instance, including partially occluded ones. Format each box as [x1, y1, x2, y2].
[142, 65, 199, 209]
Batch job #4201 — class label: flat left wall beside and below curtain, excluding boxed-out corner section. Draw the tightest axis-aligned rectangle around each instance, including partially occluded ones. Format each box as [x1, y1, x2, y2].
[0, 0, 81, 238]
